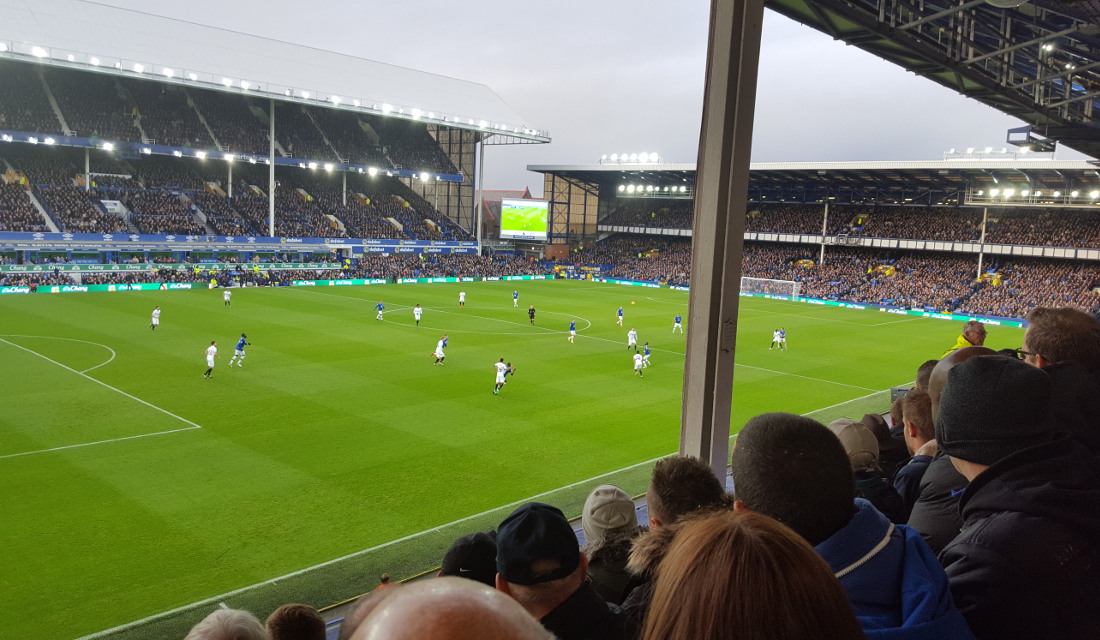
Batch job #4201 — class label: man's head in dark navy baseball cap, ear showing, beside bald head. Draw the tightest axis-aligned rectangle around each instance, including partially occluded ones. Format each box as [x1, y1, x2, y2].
[496, 503, 589, 619]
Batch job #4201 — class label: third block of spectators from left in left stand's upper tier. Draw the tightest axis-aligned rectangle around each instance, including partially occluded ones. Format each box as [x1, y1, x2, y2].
[120, 78, 213, 148]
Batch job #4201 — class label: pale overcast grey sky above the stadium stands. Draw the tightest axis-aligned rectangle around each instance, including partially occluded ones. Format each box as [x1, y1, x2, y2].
[102, 0, 1082, 196]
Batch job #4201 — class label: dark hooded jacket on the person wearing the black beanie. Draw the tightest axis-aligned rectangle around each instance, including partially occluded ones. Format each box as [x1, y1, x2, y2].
[939, 434, 1100, 640]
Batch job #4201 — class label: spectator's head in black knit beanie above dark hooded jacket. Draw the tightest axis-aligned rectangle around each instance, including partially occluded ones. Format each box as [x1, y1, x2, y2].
[936, 355, 1054, 479]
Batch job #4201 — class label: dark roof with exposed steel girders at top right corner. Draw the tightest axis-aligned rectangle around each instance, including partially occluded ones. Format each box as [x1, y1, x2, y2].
[765, 0, 1100, 158]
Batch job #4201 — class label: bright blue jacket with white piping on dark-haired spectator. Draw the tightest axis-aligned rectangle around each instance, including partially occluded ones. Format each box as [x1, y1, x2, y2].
[815, 498, 974, 640]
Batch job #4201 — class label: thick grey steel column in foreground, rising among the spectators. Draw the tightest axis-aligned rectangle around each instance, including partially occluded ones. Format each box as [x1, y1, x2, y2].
[680, 0, 763, 477]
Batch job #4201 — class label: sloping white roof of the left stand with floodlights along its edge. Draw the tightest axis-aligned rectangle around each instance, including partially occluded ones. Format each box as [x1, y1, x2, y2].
[0, 0, 549, 142]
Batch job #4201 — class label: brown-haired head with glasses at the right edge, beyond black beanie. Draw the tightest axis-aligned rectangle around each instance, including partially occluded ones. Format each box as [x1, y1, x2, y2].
[1023, 307, 1100, 372]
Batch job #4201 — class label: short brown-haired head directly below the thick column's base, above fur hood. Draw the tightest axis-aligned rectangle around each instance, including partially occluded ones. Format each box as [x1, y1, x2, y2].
[646, 455, 729, 528]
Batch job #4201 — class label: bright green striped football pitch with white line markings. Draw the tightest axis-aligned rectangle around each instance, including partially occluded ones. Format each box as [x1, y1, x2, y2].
[0, 280, 1020, 638]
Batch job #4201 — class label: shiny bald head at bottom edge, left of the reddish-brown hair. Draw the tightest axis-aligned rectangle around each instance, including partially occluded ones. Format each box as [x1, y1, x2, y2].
[352, 577, 553, 640]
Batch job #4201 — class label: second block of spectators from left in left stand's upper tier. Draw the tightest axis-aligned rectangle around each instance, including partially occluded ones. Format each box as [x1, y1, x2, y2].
[46, 69, 141, 142]
